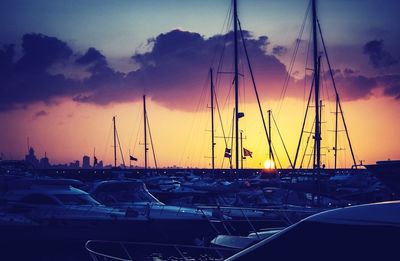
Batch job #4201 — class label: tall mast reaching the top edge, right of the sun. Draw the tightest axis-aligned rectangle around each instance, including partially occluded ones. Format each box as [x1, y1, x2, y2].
[312, 0, 321, 172]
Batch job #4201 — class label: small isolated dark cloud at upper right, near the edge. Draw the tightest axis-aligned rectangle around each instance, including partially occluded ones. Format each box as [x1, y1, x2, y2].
[363, 40, 399, 68]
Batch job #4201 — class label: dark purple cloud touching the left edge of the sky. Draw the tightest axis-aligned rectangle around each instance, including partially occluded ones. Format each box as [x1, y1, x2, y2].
[0, 34, 81, 111]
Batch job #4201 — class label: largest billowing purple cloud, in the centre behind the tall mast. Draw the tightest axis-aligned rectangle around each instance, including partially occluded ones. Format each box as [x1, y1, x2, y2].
[74, 30, 285, 110]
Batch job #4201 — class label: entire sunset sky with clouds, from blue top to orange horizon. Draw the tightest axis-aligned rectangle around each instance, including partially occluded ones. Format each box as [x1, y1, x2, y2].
[0, 0, 400, 168]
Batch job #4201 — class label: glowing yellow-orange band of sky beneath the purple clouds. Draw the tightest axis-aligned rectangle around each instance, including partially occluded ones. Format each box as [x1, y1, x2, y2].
[0, 92, 400, 168]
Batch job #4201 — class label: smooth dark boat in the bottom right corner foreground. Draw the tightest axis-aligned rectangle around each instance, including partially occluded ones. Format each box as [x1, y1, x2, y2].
[227, 201, 400, 261]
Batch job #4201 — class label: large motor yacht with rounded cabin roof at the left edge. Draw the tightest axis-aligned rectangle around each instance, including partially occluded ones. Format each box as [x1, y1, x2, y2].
[0, 179, 225, 246]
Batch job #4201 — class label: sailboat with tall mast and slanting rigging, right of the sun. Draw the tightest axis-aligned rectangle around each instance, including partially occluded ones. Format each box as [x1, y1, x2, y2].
[270, 0, 380, 205]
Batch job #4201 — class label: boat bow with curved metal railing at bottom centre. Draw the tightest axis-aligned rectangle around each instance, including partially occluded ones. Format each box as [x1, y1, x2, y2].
[85, 240, 237, 261]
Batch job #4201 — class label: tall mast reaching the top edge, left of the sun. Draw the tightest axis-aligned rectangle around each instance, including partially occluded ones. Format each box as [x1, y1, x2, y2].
[233, 0, 239, 174]
